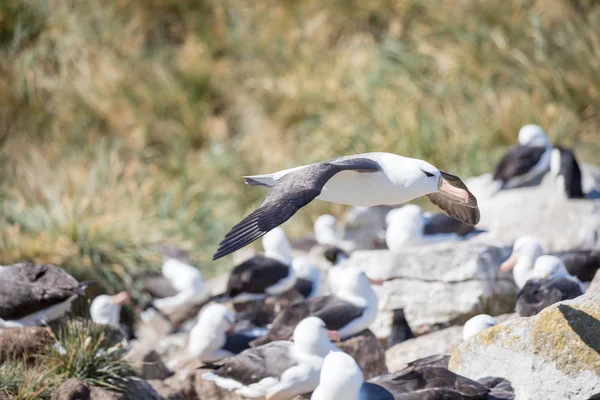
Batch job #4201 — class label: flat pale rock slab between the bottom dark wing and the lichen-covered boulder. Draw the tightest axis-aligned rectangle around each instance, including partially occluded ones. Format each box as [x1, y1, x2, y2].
[385, 326, 462, 372]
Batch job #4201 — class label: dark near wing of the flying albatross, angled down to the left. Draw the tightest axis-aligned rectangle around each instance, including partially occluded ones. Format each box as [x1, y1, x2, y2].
[213, 157, 380, 260]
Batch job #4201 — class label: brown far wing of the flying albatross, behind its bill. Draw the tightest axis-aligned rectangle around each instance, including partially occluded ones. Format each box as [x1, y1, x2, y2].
[427, 171, 480, 225]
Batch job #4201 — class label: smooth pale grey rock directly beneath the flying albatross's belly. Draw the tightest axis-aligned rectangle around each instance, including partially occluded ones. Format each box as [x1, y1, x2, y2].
[340, 206, 392, 252]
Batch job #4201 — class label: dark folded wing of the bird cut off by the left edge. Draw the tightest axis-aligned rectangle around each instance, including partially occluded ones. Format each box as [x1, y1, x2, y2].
[0, 263, 84, 320]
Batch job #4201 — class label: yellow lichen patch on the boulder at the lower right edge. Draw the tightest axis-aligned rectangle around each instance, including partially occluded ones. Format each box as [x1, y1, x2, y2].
[531, 295, 600, 376]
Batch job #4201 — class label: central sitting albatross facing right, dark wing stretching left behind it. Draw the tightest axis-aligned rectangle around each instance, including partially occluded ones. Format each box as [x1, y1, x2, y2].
[251, 267, 381, 347]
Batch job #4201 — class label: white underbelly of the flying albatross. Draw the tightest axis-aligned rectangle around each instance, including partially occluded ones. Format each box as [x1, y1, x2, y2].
[317, 171, 418, 207]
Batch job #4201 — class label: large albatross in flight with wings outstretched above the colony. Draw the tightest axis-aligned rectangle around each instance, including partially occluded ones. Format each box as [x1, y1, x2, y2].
[213, 153, 480, 260]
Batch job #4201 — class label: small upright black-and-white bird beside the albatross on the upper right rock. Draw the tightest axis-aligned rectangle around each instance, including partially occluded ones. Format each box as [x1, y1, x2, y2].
[550, 146, 585, 199]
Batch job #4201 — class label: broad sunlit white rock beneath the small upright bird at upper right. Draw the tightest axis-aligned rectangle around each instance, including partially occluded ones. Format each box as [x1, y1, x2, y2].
[466, 168, 600, 252]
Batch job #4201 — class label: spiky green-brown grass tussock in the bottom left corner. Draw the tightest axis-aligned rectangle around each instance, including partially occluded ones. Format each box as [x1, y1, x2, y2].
[0, 320, 135, 400]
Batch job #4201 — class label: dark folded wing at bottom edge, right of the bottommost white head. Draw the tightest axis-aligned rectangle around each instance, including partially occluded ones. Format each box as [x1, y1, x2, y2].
[369, 366, 490, 400]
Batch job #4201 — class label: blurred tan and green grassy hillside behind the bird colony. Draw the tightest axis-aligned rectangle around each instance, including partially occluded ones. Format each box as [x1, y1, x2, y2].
[0, 0, 600, 291]
